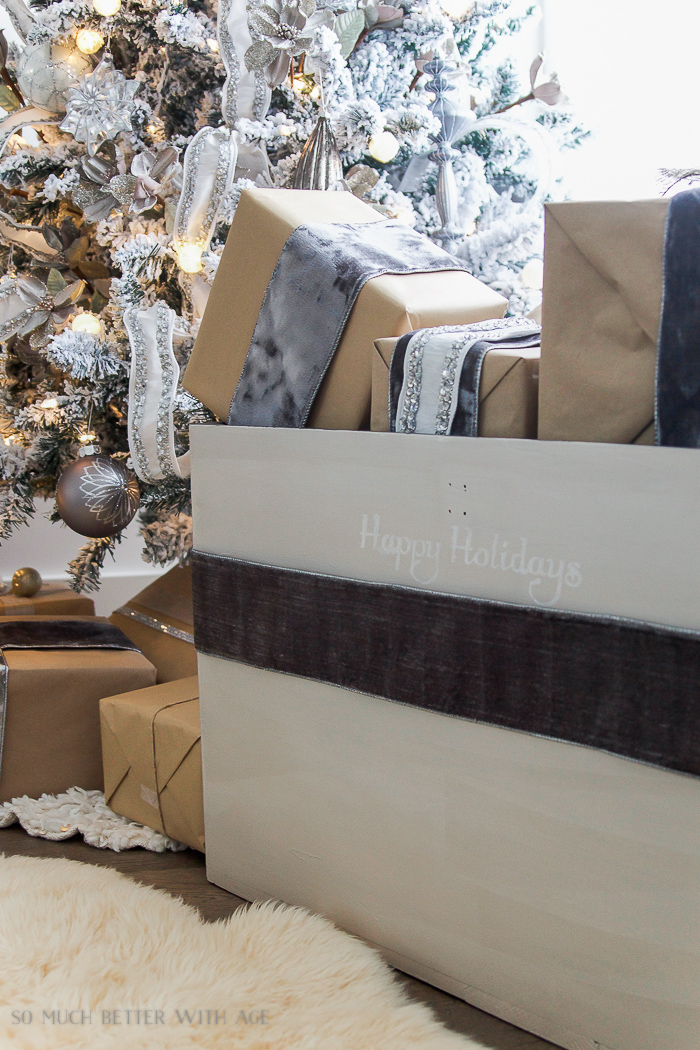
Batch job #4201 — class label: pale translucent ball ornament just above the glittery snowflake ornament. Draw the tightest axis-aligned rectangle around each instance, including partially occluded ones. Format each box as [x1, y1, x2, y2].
[17, 41, 92, 114]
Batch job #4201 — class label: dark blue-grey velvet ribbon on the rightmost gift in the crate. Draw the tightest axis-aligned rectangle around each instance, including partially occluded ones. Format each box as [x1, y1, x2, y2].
[656, 189, 700, 448]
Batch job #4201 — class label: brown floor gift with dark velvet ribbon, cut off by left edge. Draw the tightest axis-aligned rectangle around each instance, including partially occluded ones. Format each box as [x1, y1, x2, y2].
[0, 616, 155, 801]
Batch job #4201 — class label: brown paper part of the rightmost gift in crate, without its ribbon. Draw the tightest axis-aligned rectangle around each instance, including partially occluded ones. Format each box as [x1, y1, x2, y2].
[538, 201, 667, 444]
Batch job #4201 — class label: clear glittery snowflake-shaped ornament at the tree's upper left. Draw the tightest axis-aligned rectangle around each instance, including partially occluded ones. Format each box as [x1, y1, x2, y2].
[59, 54, 140, 155]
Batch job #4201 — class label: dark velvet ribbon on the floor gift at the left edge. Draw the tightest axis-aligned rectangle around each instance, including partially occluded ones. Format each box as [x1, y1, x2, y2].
[0, 618, 139, 785]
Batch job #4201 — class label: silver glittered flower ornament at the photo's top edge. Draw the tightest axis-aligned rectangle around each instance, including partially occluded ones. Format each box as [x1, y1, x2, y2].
[245, 0, 335, 87]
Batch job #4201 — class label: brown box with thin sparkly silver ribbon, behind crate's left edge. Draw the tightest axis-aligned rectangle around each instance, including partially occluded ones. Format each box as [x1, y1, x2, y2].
[109, 565, 197, 681]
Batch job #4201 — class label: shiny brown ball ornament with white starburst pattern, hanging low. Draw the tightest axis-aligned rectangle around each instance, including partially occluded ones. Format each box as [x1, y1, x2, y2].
[56, 449, 140, 540]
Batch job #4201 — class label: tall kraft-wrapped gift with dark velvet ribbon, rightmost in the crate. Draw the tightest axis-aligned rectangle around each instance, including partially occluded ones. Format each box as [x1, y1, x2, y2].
[538, 189, 700, 448]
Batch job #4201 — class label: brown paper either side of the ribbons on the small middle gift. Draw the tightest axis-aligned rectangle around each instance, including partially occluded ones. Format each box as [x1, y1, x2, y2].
[372, 339, 539, 438]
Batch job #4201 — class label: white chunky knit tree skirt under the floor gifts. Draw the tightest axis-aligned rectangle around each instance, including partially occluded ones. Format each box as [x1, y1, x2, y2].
[0, 788, 187, 853]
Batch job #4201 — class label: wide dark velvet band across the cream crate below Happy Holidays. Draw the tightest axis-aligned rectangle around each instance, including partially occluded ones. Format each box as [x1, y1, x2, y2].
[192, 551, 700, 775]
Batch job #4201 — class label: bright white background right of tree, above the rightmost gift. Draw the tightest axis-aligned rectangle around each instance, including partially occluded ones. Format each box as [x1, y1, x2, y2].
[540, 0, 700, 200]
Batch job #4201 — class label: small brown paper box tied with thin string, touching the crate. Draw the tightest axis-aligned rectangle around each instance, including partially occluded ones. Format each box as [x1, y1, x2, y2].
[100, 675, 205, 852]
